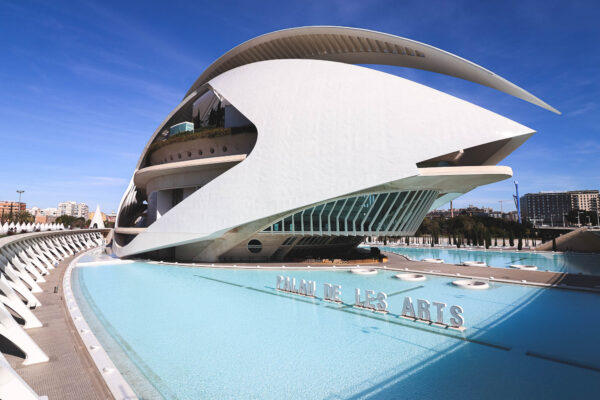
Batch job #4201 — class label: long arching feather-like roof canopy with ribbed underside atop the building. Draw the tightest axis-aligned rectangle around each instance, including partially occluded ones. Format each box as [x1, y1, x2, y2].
[185, 26, 560, 114]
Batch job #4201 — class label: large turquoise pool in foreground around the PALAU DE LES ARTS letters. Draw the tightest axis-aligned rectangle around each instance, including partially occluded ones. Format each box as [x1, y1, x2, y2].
[73, 263, 600, 399]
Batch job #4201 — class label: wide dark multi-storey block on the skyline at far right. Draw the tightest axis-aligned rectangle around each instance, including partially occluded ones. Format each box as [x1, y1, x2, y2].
[520, 190, 599, 225]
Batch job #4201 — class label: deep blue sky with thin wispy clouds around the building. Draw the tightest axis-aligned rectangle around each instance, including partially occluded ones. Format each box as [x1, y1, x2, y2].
[0, 0, 600, 212]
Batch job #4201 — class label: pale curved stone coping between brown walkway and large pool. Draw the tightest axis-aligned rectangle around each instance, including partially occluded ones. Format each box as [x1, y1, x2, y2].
[63, 248, 138, 400]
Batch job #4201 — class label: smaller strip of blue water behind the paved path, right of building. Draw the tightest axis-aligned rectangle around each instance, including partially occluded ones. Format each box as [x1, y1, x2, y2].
[381, 247, 600, 275]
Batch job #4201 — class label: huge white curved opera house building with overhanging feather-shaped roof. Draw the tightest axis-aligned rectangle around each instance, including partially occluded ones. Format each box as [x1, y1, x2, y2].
[114, 27, 558, 261]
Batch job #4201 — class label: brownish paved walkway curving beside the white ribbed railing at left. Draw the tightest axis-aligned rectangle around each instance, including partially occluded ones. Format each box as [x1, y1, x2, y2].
[0, 257, 113, 400]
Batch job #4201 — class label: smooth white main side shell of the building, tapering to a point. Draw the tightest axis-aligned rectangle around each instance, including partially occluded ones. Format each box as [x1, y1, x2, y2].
[116, 59, 534, 259]
